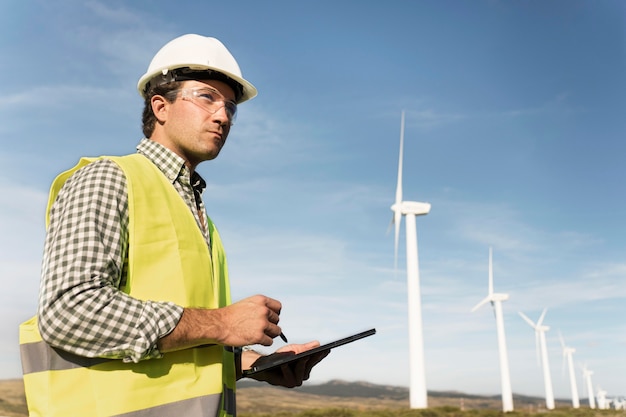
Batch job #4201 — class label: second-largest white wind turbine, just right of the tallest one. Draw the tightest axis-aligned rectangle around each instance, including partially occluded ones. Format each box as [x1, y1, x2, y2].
[472, 248, 513, 413]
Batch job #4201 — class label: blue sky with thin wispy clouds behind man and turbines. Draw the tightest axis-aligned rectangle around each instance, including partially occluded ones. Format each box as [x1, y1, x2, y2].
[0, 0, 626, 398]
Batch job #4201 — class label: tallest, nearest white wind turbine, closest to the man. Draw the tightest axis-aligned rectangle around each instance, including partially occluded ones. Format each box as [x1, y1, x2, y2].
[391, 111, 430, 408]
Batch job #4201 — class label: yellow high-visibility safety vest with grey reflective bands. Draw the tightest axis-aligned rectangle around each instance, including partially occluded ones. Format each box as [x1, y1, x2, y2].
[20, 154, 236, 417]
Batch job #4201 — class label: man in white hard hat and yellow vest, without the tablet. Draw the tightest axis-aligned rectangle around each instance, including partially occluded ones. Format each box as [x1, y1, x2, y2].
[20, 35, 328, 417]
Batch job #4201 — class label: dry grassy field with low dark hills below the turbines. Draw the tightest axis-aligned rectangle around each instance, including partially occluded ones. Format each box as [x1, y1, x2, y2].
[0, 380, 626, 417]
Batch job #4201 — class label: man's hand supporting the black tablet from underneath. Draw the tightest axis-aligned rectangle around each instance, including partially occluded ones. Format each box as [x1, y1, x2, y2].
[241, 341, 330, 388]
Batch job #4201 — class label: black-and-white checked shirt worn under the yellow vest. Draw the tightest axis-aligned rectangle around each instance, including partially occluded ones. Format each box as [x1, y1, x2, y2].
[38, 139, 210, 362]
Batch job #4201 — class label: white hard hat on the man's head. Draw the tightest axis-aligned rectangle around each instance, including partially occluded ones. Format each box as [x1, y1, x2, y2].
[137, 34, 257, 103]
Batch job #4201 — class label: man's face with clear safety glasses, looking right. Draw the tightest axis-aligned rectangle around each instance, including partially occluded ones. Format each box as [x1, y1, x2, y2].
[154, 80, 236, 169]
